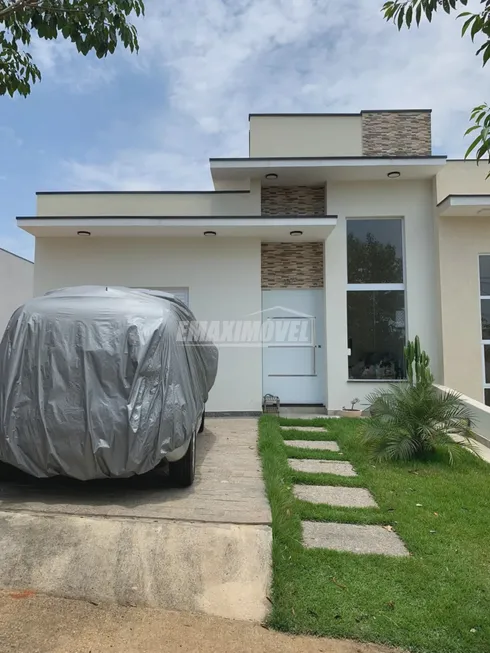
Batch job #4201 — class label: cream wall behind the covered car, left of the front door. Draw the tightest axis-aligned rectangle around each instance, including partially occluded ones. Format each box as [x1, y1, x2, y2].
[35, 238, 262, 411]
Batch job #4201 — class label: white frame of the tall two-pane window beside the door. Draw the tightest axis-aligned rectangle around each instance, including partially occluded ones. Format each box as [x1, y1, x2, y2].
[345, 215, 408, 382]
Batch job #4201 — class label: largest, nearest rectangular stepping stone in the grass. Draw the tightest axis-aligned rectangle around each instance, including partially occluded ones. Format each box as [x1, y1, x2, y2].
[302, 521, 408, 556]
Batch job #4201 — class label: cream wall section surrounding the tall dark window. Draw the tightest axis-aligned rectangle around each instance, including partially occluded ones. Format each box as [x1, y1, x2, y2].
[325, 181, 442, 410]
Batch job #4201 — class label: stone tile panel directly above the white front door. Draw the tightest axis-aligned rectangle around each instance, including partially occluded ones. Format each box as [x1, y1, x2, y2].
[262, 243, 324, 290]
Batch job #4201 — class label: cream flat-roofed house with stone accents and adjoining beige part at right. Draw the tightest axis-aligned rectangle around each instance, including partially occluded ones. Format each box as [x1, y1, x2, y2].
[18, 110, 490, 413]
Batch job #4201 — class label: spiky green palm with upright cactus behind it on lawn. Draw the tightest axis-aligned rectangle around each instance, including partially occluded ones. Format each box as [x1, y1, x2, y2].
[363, 338, 474, 464]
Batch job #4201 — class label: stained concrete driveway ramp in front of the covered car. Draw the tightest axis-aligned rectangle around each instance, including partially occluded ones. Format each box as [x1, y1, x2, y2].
[0, 512, 272, 622]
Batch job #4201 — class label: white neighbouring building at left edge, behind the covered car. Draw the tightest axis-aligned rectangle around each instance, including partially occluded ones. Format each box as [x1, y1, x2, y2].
[0, 247, 34, 339]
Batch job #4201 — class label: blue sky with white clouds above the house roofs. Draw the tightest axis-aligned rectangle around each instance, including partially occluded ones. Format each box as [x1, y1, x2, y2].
[0, 0, 490, 259]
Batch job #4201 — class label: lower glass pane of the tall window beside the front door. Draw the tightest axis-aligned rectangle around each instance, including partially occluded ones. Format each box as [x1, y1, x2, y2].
[347, 290, 405, 380]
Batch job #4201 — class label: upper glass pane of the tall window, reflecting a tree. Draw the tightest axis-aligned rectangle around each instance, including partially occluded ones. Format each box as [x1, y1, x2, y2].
[347, 219, 403, 284]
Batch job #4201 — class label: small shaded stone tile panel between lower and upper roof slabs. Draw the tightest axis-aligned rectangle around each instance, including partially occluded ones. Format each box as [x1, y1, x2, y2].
[262, 186, 325, 215]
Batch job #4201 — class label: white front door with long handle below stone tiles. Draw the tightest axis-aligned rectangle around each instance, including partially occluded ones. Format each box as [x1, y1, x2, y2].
[262, 288, 326, 404]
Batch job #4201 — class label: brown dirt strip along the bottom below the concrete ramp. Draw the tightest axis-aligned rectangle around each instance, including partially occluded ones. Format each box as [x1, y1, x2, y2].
[0, 592, 402, 653]
